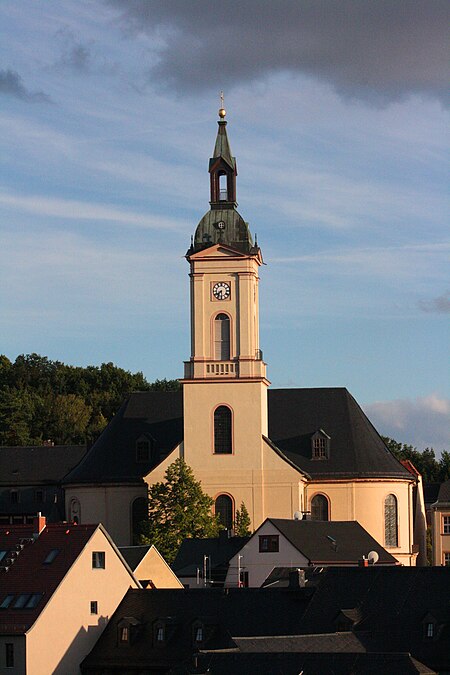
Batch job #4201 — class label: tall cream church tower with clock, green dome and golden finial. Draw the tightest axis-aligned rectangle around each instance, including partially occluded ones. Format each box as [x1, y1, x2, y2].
[182, 108, 269, 527]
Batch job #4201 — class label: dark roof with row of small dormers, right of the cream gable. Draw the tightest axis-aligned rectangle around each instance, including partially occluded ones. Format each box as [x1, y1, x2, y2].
[83, 588, 308, 672]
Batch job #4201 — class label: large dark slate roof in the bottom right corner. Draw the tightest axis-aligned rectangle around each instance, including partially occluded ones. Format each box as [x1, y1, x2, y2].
[298, 565, 450, 671]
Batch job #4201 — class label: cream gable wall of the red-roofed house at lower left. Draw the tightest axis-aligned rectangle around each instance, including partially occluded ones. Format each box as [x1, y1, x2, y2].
[26, 528, 139, 675]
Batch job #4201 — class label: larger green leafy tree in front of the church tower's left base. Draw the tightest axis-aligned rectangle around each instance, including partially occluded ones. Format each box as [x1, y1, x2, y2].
[139, 458, 221, 563]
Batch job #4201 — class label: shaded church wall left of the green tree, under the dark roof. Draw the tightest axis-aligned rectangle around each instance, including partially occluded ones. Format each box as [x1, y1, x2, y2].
[65, 483, 147, 546]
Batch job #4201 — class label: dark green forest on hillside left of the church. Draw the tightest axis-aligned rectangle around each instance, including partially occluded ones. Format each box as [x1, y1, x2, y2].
[0, 354, 180, 446]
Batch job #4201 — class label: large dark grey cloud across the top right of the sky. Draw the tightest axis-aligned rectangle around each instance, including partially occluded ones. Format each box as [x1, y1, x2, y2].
[105, 0, 450, 102]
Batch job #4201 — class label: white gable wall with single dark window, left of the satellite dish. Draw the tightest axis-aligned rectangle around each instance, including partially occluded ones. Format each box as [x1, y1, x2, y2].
[225, 522, 308, 588]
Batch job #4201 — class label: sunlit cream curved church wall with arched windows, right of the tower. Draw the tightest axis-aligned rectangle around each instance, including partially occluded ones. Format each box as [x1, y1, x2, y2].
[306, 479, 417, 566]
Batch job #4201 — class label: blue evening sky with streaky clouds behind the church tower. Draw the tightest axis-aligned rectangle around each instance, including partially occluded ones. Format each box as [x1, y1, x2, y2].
[0, 0, 450, 453]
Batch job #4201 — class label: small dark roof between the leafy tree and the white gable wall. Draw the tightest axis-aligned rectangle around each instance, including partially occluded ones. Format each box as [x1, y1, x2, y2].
[171, 531, 250, 577]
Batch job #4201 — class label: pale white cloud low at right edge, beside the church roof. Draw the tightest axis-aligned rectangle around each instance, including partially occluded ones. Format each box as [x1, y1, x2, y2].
[363, 393, 450, 452]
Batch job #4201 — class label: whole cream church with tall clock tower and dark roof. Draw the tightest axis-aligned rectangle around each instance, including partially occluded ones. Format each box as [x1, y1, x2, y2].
[65, 108, 424, 566]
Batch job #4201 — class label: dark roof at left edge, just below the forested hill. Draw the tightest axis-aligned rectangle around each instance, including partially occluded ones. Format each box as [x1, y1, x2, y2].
[0, 445, 86, 487]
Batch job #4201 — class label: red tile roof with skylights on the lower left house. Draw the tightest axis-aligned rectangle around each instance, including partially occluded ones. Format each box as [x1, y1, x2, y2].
[0, 523, 99, 634]
